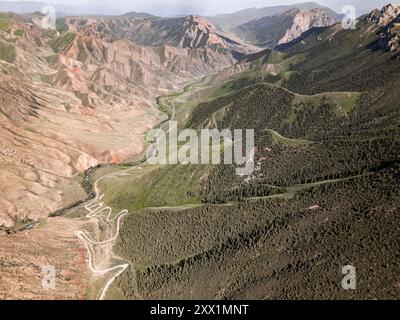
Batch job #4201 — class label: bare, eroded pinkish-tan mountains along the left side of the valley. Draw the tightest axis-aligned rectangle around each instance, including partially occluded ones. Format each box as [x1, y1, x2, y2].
[0, 10, 252, 225]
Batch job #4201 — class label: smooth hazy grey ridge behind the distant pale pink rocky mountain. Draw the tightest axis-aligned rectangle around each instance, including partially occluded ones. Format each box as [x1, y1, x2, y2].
[209, 2, 341, 31]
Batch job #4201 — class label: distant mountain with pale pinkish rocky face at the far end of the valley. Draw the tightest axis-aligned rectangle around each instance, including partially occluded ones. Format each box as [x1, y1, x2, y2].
[233, 9, 336, 49]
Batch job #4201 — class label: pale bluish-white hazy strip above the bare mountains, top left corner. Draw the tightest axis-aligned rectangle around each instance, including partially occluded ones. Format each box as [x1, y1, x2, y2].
[0, 1, 123, 15]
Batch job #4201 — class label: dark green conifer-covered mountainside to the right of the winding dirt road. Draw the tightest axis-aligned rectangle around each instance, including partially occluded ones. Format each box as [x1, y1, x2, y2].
[113, 6, 400, 299]
